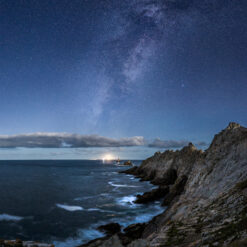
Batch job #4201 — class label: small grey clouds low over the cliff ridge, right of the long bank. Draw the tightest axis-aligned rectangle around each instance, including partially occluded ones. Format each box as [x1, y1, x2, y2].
[148, 138, 207, 148]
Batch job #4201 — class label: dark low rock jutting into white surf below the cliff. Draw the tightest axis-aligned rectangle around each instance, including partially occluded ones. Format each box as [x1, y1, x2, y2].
[135, 186, 169, 203]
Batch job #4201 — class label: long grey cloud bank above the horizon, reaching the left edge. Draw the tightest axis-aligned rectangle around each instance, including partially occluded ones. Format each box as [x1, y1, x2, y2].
[0, 133, 145, 148]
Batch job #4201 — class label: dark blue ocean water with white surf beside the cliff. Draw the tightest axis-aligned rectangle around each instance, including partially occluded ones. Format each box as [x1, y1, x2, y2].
[0, 160, 162, 247]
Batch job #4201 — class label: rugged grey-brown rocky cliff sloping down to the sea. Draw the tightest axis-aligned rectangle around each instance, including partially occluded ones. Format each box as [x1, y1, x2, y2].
[82, 123, 247, 247]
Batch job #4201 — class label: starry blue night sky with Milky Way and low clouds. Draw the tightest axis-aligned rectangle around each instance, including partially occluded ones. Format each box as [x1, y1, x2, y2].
[0, 0, 247, 159]
